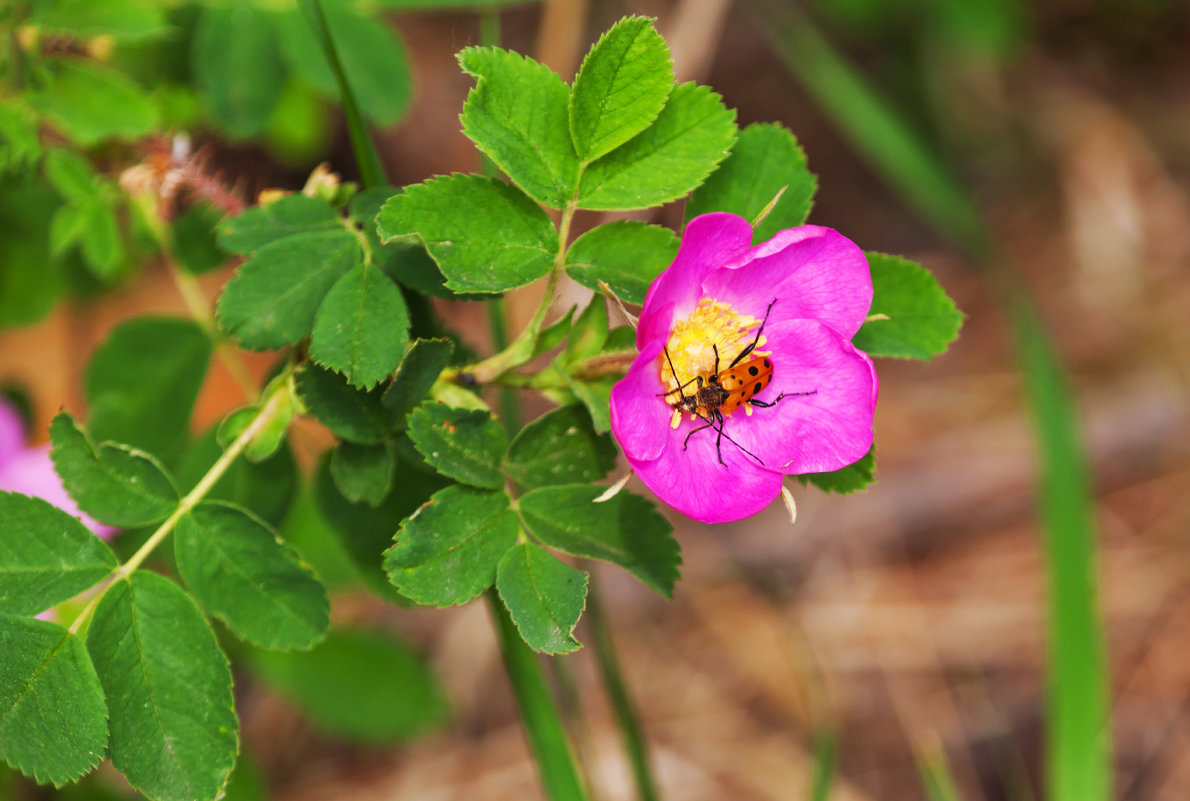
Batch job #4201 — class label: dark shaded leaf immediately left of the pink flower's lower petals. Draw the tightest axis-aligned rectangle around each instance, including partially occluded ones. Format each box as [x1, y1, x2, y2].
[505, 406, 616, 487]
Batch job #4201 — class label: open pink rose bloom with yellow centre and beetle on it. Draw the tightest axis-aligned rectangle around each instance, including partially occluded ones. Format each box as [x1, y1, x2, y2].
[612, 213, 878, 522]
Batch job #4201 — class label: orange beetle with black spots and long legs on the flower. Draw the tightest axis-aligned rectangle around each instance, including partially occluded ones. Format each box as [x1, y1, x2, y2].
[662, 298, 818, 467]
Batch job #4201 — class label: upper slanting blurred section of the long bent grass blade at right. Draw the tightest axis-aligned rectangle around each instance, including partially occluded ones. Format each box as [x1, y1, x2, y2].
[752, 0, 988, 252]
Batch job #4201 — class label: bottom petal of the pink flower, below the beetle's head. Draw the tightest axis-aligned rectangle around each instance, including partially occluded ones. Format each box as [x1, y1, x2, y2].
[628, 421, 782, 522]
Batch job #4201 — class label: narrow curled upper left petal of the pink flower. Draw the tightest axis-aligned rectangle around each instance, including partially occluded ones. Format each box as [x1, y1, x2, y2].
[637, 212, 752, 350]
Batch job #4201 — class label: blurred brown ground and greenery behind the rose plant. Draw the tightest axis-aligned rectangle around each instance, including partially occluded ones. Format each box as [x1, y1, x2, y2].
[0, 0, 1190, 801]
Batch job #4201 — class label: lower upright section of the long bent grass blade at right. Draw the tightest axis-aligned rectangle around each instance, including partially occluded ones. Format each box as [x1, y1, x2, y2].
[1013, 299, 1111, 801]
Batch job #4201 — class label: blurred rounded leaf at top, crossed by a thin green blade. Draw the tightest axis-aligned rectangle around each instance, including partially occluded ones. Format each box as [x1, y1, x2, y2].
[277, 2, 413, 125]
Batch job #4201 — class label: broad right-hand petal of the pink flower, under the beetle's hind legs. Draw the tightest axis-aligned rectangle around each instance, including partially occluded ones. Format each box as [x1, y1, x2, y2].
[726, 320, 879, 474]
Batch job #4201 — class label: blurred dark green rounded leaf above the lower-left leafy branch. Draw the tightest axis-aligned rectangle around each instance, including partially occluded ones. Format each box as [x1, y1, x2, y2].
[83, 317, 212, 461]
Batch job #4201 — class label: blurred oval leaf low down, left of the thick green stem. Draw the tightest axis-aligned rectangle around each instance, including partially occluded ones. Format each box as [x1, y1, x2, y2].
[248, 627, 449, 745]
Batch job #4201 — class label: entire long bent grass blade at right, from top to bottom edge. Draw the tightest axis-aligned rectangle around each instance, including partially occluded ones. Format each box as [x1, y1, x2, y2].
[752, 0, 1111, 801]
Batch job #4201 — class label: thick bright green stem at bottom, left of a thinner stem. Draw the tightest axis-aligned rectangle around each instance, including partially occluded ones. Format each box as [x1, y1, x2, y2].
[488, 590, 589, 801]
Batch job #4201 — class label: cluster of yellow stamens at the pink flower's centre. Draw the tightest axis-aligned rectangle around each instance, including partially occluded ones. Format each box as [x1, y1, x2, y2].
[660, 298, 770, 427]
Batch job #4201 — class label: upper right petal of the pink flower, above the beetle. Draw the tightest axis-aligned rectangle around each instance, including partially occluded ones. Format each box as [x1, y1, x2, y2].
[702, 225, 872, 339]
